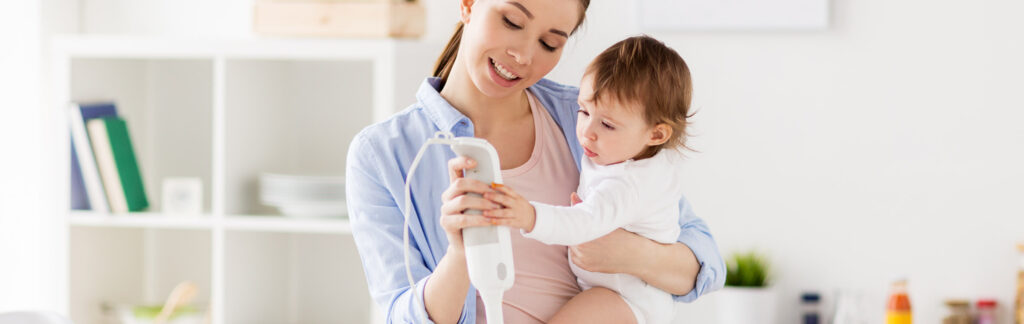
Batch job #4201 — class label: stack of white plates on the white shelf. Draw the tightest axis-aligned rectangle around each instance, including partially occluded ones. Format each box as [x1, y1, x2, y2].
[259, 173, 347, 217]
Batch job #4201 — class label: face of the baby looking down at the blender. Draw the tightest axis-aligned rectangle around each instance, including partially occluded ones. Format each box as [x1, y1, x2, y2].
[577, 75, 653, 165]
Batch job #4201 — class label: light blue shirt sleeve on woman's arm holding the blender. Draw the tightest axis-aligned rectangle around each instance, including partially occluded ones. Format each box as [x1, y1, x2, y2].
[345, 133, 473, 323]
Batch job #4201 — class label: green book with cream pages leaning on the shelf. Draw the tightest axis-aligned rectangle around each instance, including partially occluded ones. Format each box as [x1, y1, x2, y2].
[86, 117, 150, 213]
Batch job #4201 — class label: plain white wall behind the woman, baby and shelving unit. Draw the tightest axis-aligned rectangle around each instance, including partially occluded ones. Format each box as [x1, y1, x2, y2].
[0, 0, 1024, 323]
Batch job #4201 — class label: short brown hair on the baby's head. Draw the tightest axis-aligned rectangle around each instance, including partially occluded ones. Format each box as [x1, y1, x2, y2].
[586, 35, 693, 160]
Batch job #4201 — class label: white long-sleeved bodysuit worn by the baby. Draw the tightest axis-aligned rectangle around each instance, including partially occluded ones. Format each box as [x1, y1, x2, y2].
[523, 150, 683, 324]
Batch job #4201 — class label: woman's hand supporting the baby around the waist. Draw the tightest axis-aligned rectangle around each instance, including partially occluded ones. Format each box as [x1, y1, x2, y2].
[569, 229, 656, 277]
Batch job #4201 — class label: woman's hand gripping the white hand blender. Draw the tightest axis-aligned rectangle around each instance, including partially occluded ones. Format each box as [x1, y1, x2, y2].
[441, 157, 501, 251]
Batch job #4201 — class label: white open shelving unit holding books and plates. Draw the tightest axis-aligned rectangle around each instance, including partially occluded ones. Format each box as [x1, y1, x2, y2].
[51, 36, 440, 324]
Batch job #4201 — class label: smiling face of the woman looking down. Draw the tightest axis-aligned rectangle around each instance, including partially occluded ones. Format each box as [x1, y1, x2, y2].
[457, 0, 581, 97]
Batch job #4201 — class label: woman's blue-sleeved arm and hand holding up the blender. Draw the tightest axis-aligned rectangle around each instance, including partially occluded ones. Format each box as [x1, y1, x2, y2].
[346, 134, 499, 323]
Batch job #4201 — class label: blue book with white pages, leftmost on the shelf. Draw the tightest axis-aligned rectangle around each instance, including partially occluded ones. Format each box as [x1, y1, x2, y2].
[68, 103, 118, 212]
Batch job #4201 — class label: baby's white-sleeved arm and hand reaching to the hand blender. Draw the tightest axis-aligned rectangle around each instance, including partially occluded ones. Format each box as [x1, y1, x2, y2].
[483, 179, 639, 245]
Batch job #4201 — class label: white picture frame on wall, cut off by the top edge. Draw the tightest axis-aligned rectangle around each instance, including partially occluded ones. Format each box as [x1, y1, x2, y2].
[635, 0, 829, 31]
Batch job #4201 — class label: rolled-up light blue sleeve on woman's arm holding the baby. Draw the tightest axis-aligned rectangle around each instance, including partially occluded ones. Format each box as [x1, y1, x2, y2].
[673, 197, 725, 302]
